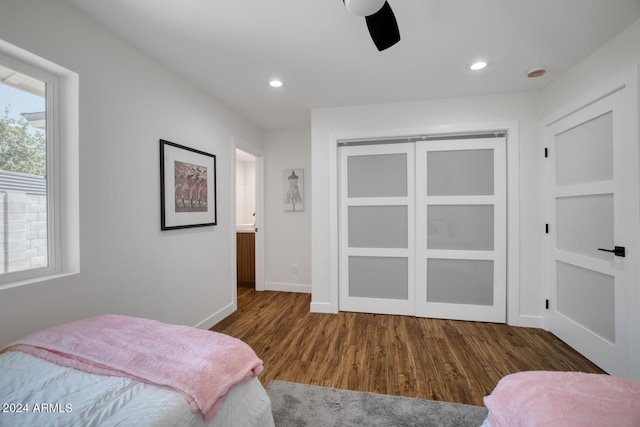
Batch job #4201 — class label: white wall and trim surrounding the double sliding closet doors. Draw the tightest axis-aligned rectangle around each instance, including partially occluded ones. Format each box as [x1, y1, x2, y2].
[311, 93, 543, 326]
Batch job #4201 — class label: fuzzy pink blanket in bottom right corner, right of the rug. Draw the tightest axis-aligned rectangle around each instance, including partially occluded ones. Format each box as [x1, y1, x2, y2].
[484, 371, 640, 427]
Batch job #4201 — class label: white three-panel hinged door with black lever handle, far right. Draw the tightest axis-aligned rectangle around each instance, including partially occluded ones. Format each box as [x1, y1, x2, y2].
[545, 89, 638, 376]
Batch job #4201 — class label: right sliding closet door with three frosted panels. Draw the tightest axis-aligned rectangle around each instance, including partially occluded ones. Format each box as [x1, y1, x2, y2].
[416, 138, 506, 322]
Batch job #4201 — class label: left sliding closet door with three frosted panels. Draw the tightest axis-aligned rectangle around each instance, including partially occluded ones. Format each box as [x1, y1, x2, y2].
[339, 144, 415, 315]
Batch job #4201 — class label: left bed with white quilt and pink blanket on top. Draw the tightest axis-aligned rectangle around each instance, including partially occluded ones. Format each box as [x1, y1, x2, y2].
[0, 315, 274, 427]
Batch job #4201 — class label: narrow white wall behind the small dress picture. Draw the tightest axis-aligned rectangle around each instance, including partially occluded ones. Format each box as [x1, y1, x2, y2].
[264, 129, 315, 292]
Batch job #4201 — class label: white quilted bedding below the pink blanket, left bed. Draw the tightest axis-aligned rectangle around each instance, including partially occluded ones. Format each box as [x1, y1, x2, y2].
[0, 351, 274, 427]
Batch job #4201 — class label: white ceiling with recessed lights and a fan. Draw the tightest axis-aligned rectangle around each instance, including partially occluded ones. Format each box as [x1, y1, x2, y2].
[67, 0, 640, 129]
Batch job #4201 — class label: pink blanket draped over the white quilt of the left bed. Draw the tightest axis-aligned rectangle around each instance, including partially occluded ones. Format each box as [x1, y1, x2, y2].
[0, 315, 262, 421]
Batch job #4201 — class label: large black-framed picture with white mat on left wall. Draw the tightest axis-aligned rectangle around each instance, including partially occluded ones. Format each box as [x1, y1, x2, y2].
[160, 139, 217, 230]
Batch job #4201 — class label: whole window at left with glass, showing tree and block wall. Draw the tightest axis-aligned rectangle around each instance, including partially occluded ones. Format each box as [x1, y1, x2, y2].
[0, 40, 78, 286]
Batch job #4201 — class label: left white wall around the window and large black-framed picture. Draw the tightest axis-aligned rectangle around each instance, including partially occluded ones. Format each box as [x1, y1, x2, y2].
[0, 0, 262, 346]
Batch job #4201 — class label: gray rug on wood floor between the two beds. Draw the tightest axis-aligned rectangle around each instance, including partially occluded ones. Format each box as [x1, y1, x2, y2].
[267, 380, 487, 427]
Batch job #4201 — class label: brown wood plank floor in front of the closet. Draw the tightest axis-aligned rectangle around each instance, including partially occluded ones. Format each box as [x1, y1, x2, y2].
[211, 287, 602, 405]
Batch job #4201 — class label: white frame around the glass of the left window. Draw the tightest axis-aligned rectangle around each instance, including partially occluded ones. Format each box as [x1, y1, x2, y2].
[0, 39, 79, 290]
